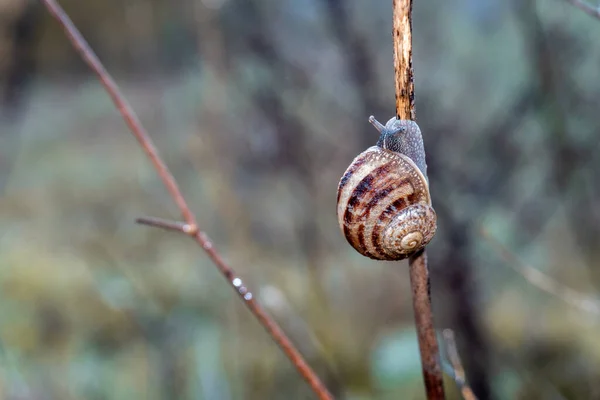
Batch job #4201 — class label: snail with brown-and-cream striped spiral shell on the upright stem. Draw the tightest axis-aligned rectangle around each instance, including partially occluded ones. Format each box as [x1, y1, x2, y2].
[337, 116, 437, 261]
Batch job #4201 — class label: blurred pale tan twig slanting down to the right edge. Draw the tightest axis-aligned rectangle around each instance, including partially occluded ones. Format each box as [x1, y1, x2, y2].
[480, 228, 600, 315]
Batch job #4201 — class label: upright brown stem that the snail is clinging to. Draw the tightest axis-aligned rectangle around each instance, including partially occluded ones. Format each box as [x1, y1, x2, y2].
[392, 0, 445, 400]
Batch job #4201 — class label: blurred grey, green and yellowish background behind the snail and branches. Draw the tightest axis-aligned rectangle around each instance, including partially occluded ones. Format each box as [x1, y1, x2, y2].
[0, 0, 600, 400]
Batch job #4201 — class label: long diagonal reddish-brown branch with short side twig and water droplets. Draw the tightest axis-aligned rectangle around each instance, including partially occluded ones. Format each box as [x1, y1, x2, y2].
[42, 0, 333, 400]
